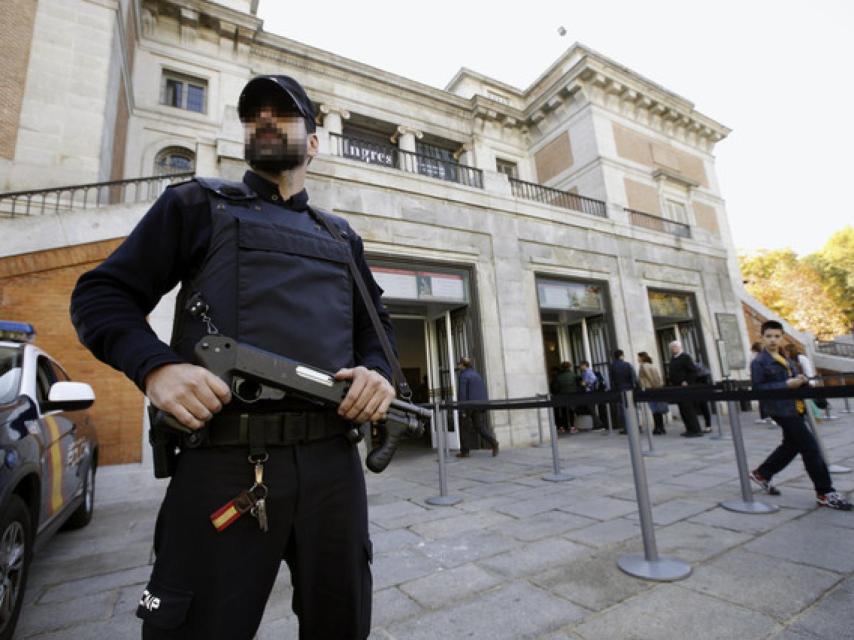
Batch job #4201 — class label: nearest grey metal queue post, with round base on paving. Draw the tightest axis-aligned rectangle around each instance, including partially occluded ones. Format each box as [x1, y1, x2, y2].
[617, 391, 691, 582]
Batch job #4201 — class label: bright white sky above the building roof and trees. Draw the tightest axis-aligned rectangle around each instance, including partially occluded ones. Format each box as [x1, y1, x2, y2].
[258, 0, 854, 255]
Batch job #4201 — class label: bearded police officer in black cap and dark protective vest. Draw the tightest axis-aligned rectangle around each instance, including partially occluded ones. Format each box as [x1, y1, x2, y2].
[71, 75, 394, 640]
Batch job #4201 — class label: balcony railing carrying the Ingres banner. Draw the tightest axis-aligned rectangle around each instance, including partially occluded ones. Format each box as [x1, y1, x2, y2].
[329, 133, 483, 189]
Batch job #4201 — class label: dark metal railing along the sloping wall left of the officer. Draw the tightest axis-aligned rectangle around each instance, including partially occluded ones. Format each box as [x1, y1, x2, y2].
[0, 172, 193, 218]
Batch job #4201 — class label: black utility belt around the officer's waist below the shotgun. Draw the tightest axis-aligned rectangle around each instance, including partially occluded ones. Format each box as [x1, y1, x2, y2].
[181, 411, 350, 449]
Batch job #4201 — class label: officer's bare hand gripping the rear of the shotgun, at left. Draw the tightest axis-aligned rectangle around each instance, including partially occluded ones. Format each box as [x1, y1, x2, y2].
[145, 364, 231, 429]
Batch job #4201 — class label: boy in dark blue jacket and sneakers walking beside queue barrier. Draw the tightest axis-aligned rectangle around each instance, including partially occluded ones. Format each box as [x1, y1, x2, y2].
[750, 320, 851, 511]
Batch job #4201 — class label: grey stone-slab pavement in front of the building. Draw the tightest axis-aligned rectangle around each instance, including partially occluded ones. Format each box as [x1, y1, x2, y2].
[16, 414, 854, 640]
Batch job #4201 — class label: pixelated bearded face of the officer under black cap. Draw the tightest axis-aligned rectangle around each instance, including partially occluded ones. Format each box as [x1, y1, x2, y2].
[244, 103, 317, 174]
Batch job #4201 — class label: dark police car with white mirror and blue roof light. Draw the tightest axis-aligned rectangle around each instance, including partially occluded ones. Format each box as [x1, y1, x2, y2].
[0, 321, 98, 640]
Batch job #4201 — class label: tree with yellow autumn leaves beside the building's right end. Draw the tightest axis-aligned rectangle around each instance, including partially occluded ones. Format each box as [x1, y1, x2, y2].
[739, 226, 854, 340]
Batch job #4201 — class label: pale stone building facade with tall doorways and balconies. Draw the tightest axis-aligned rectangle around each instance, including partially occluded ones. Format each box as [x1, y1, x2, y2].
[0, 0, 748, 460]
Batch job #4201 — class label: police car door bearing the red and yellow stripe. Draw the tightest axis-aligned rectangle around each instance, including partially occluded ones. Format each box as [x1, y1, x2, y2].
[36, 355, 74, 528]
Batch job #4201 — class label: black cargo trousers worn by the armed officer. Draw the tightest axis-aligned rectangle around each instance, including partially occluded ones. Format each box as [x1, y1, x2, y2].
[137, 436, 372, 640]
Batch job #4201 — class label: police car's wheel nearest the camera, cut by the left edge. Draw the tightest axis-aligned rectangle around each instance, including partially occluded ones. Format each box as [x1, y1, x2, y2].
[0, 494, 32, 640]
